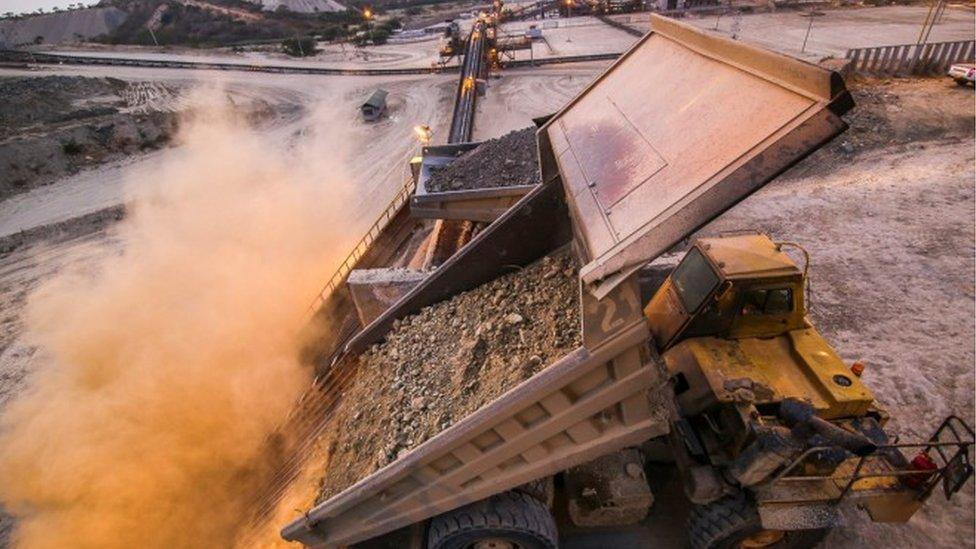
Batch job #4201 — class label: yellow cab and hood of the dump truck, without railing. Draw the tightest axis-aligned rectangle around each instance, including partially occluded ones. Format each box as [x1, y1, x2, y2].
[645, 234, 880, 419]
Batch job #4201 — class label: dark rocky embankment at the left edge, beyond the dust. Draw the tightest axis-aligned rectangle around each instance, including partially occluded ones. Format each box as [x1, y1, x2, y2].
[0, 76, 178, 199]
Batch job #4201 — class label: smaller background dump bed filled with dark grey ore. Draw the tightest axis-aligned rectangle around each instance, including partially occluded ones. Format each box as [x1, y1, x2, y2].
[410, 128, 539, 222]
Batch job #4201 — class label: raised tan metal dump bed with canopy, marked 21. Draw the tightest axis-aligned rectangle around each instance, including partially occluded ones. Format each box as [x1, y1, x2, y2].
[282, 17, 852, 547]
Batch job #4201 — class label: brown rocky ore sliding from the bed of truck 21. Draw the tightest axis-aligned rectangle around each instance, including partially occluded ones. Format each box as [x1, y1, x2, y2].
[318, 252, 581, 502]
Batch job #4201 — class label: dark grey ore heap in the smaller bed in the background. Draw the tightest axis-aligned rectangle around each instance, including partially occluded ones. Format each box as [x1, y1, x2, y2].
[426, 126, 542, 192]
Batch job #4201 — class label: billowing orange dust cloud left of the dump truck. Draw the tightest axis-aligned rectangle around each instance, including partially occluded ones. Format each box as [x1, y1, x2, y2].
[0, 90, 358, 549]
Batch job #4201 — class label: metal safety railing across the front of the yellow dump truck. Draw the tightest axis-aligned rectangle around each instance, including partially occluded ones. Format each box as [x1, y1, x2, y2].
[762, 416, 974, 505]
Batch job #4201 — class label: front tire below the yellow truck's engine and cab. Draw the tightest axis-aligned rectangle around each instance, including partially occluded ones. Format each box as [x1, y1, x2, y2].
[688, 494, 828, 549]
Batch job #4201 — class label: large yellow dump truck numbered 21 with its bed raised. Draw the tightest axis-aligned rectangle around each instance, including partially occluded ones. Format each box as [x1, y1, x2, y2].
[282, 17, 972, 549]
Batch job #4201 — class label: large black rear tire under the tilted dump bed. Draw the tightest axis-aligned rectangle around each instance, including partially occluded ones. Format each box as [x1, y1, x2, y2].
[427, 492, 559, 549]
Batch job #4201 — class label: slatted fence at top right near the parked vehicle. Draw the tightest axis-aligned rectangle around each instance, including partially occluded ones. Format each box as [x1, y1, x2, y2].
[847, 40, 976, 75]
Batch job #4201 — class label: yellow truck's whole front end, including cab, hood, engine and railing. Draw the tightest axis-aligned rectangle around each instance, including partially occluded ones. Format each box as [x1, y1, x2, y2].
[644, 233, 972, 547]
